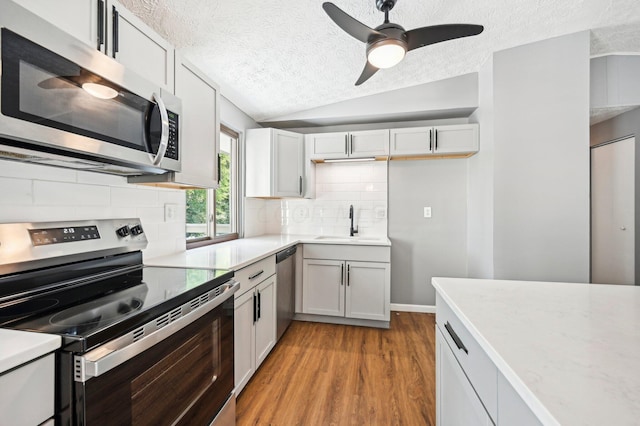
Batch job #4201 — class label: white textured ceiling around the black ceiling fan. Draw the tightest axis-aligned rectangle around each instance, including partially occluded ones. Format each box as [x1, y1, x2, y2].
[121, 0, 640, 121]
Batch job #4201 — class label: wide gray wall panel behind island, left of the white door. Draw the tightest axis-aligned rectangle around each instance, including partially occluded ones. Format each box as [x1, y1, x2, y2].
[493, 31, 590, 282]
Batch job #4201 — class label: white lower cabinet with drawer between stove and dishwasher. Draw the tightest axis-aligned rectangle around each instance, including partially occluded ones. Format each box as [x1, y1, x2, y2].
[234, 256, 276, 395]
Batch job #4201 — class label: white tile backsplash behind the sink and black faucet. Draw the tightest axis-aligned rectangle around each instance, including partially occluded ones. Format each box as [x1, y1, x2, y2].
[247, 161, 387, 236]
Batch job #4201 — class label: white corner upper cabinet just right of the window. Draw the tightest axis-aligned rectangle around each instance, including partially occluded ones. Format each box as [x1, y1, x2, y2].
[245, 128, 304, 198]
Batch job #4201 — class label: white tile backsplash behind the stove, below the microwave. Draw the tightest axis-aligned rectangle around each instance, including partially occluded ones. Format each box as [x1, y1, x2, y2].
[0, 160, 185, 258]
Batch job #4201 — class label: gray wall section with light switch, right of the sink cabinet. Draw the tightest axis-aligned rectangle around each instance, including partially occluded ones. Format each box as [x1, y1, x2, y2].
[389, 159, 467, 305]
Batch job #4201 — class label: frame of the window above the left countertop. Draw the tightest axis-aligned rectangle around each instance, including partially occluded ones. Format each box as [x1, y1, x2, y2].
[185, 124, 241, 250]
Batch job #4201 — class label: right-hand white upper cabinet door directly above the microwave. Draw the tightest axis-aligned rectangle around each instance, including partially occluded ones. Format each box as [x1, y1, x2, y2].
[105, 0, 174, 93]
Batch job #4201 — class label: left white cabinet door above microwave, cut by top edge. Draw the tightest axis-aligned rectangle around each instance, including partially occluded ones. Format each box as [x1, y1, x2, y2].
[14, 0, 99, 49]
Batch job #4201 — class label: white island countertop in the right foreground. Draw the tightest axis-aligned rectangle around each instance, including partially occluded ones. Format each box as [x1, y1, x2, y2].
[432, 278, 640, 426]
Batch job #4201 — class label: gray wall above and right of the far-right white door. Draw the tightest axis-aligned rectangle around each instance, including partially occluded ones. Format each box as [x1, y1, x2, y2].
[591, 107, 640, 285]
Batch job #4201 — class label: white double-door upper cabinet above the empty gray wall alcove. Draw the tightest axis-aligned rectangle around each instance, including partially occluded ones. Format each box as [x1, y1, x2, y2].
[390, 124, 479, 158]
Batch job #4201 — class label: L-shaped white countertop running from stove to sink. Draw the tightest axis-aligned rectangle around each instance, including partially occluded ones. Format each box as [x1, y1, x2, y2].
[144, 234, 391, 271]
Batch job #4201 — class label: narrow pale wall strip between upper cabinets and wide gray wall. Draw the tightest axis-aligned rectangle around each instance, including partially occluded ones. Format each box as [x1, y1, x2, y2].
[467, 58, 494, 278]
